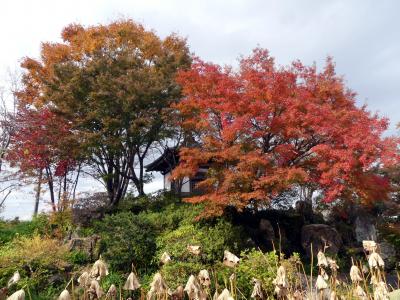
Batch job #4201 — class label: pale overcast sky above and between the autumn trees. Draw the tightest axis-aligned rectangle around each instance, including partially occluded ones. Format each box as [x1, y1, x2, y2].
[0, 0, 400, 218]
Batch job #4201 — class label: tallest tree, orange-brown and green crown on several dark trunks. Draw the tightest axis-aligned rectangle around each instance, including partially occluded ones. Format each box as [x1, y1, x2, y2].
[18, 20, 190, 205]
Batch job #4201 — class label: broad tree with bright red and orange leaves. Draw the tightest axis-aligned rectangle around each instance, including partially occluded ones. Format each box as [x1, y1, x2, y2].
[174, 49, 398, 214]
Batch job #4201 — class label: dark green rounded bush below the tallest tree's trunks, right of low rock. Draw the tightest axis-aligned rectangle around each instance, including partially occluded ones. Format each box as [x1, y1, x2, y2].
[95, 212, 156, 272]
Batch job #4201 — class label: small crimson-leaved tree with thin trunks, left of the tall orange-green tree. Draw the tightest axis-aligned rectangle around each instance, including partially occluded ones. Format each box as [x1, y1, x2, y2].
[7, 106, 80, 215]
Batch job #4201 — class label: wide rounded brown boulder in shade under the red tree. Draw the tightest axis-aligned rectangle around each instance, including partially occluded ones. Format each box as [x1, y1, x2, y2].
[301, 224, 342, 255]
